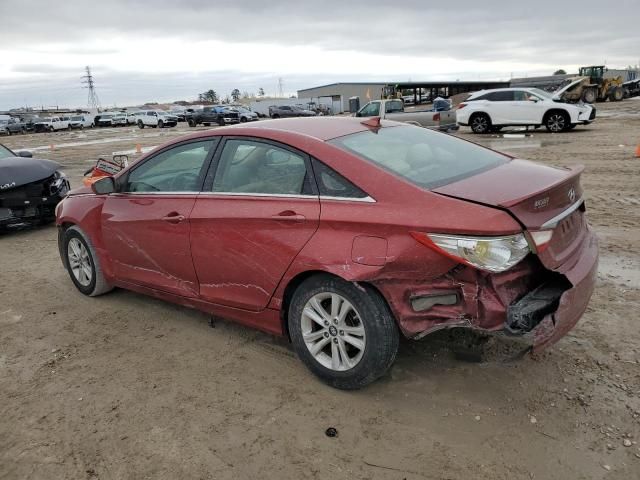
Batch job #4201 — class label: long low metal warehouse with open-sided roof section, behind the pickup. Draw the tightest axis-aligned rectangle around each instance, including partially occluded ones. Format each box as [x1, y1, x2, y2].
[298, 81, 509, 113]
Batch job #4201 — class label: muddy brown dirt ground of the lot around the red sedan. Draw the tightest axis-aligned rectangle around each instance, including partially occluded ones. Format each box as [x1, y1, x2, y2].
[0, 100, 640, 480]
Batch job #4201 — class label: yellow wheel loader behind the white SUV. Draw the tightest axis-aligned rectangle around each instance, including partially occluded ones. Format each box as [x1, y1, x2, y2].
[557, 65, 624, 103]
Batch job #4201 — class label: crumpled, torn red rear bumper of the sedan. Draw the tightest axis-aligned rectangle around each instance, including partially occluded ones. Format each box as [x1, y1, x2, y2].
[374, 229, 598, 350]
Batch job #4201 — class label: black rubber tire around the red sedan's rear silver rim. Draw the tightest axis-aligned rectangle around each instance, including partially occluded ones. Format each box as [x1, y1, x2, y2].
[288, 275, 399, 390]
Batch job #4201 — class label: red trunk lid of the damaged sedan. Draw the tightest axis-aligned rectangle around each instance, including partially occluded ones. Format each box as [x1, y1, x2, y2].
[434, 159, 587, 270]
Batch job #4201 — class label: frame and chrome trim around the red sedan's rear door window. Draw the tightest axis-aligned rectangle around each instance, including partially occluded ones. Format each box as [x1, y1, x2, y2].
[202, 135, 319, 198]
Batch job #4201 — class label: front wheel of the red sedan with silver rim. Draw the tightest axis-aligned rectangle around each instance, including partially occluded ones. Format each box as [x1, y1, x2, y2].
[62, 226, 113, 297]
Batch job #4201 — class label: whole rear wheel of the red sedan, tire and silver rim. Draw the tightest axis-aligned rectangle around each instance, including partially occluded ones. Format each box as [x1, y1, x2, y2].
[288, 275, 399, 390]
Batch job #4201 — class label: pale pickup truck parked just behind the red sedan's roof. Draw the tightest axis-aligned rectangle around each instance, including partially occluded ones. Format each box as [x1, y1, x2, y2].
[356, 99, 459, 131]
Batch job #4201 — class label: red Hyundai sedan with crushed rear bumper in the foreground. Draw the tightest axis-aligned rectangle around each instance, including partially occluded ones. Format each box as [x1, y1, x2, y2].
[57, 118, 598, 389]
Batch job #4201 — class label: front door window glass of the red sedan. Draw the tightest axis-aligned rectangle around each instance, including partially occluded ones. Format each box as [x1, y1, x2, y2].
[124, 139, 218, 192]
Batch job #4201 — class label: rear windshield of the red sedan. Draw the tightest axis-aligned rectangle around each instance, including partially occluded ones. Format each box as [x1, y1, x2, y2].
[329, 125, 508, 189]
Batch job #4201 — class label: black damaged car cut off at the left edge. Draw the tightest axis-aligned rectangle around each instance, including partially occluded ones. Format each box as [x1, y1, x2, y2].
[0, 144, 70, 231]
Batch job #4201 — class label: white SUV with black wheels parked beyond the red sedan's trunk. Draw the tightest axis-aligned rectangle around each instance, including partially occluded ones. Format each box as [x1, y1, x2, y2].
[456, 88, 596, 133]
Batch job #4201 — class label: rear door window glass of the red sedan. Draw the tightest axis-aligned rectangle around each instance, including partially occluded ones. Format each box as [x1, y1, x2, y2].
[213, 140, 311, 195]
